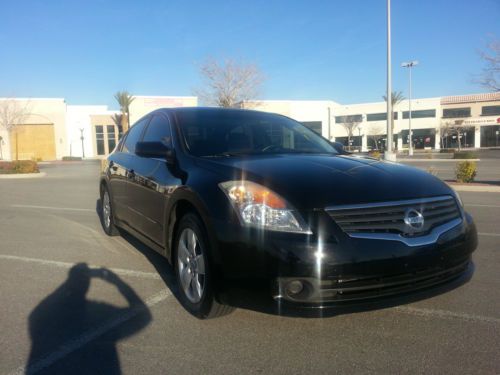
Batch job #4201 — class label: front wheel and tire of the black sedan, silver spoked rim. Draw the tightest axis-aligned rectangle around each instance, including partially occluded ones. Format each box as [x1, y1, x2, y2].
[173, 213, 234, 319]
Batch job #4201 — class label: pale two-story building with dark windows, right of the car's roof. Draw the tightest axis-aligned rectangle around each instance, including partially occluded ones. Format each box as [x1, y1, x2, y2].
[241, 93, 500, 151]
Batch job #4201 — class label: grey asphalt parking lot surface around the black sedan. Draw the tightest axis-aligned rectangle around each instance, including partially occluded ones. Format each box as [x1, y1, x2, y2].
[0, 162, 500, 374]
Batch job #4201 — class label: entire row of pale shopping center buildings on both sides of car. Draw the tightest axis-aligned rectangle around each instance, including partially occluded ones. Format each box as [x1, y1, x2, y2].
[0, 93, 500, 160]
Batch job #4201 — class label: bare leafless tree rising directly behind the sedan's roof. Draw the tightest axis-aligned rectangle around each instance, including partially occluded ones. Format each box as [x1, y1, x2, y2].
[196, 59, 264, 108]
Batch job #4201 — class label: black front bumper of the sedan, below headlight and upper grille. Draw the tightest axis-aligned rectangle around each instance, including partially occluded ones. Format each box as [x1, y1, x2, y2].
[211, 213, 477, 308]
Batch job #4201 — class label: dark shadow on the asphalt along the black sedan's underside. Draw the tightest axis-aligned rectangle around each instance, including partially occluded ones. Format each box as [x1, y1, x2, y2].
[96, 199, 475, 318]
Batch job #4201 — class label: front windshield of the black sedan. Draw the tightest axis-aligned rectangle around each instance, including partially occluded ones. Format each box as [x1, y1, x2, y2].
[177, 111, 337, 157]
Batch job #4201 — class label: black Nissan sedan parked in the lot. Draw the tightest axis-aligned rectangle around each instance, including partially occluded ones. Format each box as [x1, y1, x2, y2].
[100, 108, 477, 318]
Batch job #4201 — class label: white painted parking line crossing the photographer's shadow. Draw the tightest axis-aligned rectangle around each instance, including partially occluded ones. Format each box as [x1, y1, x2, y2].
[10, 289, 172, 375]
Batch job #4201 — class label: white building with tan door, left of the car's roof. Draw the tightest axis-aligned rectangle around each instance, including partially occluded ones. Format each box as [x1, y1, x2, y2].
[0, 96, 198, 160]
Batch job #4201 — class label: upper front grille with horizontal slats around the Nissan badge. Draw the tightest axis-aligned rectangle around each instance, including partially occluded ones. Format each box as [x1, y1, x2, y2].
[326, 196, 460, 237]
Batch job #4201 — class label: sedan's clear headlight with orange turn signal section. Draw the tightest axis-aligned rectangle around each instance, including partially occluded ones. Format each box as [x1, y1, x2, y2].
[219, 181, 311, 234]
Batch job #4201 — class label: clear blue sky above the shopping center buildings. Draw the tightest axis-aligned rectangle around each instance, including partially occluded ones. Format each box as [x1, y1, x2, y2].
[0, 0, 500, 108]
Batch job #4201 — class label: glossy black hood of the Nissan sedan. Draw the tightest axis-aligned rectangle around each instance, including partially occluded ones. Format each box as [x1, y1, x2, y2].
[195, 154, 452, 209]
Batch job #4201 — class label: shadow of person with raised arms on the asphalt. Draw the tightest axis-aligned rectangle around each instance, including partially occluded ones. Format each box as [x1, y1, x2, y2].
[25, 263, 152, 374]
